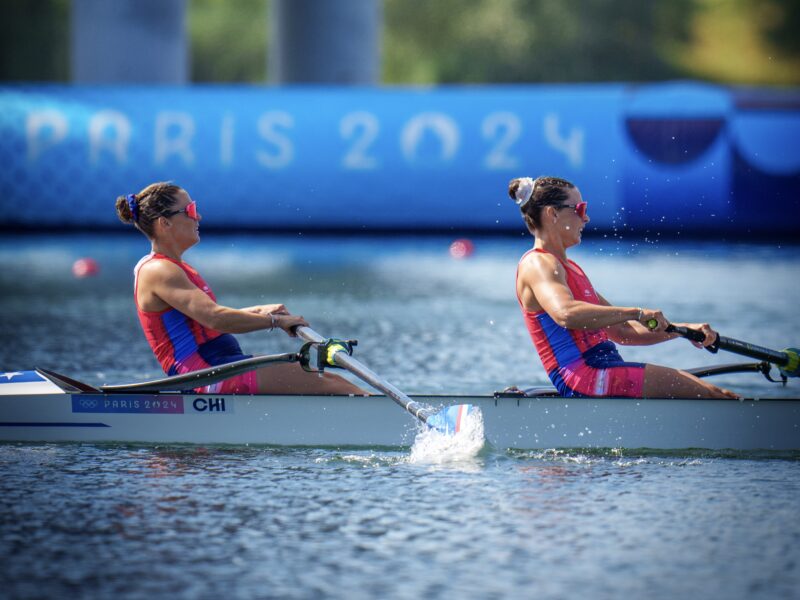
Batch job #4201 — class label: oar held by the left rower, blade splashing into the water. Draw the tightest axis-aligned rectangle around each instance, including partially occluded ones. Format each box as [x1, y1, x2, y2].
[295, 327, 479, 434]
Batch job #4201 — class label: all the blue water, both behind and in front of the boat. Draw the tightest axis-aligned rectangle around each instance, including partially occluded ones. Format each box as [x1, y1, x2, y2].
[0, 236, 800, 600]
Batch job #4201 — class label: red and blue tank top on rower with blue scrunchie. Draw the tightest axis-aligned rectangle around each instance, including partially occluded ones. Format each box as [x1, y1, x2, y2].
[133, 253, 236, 374]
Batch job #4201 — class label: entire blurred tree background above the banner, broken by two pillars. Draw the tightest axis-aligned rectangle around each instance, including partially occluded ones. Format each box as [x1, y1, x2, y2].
[0, 0, 800, 85]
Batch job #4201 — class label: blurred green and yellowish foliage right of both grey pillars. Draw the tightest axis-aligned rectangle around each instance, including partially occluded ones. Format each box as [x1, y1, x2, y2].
[383, 0, 800, 84]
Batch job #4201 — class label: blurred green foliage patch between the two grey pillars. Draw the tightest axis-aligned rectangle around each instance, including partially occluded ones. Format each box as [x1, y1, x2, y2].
[188, 0, 267, 83]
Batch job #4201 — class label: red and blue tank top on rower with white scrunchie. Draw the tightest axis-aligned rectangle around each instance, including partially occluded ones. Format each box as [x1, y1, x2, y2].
[517, 248, 613, 374]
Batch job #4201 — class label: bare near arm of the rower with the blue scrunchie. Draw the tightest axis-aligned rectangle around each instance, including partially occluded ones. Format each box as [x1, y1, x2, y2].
[139, 260, 307, 333]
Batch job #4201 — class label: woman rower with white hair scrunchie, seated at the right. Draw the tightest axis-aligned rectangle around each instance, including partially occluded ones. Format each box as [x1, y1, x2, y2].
[508, 177, 737, 398]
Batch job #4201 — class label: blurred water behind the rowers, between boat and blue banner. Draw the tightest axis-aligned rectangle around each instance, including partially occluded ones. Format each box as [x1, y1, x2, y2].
[0, 234, 800, 396]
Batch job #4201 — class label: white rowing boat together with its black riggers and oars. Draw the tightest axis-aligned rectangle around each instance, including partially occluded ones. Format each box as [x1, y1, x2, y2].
[0, 326, 800, 451]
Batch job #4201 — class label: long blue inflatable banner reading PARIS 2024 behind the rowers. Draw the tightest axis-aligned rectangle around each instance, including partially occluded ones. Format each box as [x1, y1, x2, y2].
[0, 83, 800, 233]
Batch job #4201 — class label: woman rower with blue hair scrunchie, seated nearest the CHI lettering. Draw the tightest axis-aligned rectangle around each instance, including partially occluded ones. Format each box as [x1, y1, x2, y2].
[116, 183, 365, 395]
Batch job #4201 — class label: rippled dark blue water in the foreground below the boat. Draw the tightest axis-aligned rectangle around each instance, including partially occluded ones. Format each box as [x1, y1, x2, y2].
[0, 445, 800, 599]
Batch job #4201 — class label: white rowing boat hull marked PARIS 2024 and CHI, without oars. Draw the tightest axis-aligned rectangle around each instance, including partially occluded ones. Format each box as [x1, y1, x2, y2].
[0, 371, 800, 451]
